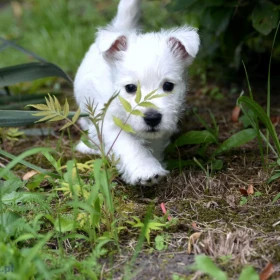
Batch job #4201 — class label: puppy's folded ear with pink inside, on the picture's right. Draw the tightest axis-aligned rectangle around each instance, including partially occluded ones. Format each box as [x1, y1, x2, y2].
[167, 26, 200, 66]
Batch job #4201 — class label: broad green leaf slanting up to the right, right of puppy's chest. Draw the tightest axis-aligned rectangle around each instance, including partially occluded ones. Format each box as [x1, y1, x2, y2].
[214, 128, 257, 155]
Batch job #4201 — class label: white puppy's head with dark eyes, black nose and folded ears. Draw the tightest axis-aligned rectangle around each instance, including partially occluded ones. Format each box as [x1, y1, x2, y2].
[97, 27, 199, 139]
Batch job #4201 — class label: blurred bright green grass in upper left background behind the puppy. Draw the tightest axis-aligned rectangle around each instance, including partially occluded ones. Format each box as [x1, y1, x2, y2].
[0, 0, 117, 73]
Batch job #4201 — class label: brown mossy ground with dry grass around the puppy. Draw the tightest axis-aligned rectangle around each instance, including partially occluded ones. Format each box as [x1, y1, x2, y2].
[2, 79, 280, 279]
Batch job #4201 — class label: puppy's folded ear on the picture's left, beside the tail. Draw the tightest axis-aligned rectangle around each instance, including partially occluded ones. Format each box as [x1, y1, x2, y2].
[96, 29, 127, 61]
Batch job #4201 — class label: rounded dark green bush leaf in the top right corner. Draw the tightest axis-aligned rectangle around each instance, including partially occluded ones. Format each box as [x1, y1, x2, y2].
[252, 1, 279, 35]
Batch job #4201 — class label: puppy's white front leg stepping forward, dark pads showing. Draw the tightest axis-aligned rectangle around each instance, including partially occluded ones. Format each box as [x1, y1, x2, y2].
[105, 131, 168, 186]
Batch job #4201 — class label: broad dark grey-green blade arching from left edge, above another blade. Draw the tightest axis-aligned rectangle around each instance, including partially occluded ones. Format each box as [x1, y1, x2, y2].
[0, 62, 73, 87]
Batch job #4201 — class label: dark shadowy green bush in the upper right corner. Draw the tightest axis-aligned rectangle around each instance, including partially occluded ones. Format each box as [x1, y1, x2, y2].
[168, 0, 280, 78]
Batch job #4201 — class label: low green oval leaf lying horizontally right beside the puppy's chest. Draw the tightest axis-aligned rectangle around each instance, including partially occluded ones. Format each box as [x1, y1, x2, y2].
[175, 130, 217, 147]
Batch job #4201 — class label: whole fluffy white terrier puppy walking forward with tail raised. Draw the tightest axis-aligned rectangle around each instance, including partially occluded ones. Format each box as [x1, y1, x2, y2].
[74, 0, 199, 186]
